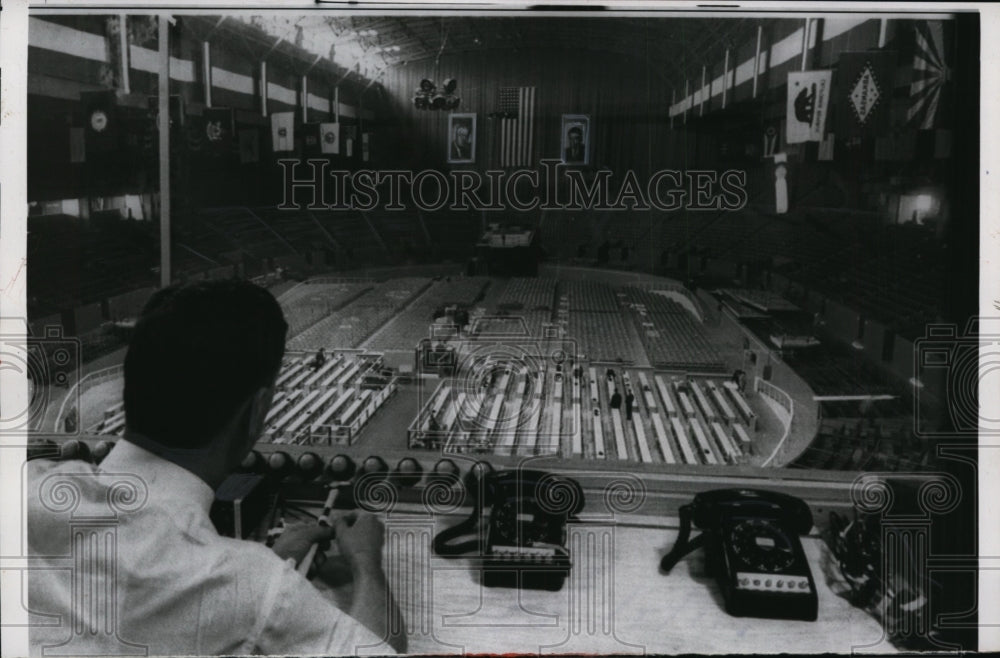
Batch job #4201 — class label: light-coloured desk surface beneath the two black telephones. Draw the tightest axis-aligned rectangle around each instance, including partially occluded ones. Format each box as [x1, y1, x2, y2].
[316, 513, 893, 654]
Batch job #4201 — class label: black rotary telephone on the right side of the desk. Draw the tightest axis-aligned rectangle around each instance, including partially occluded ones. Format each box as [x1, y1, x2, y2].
[660, 489, 818, 621]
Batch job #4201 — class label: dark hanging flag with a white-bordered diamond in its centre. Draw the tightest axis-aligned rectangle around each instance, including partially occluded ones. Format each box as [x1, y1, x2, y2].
[834, 51, 896, 139]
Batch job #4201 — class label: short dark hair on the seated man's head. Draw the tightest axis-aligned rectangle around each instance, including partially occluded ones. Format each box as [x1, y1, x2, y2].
[124, 280, 288, 448]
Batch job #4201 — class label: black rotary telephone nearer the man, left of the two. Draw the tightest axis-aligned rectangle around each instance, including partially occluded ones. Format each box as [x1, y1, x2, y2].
[434, 469, 583, 591]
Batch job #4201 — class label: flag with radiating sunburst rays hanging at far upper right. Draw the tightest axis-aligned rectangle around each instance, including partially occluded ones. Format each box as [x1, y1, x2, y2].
[907, 21, 951, 130]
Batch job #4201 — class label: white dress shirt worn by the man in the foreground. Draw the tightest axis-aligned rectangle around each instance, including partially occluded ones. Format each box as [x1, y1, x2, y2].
[27, 441, 394, 655]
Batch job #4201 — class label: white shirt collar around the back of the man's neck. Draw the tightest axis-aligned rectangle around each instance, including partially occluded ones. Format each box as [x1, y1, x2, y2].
[99, 439, 215, 513]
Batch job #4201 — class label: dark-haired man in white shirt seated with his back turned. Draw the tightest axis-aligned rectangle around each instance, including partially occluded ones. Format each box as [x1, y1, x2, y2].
[28, 281, 406, 655]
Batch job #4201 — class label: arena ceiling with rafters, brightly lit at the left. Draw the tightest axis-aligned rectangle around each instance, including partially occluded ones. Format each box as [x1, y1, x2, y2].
[184, 13, 772, 88]
